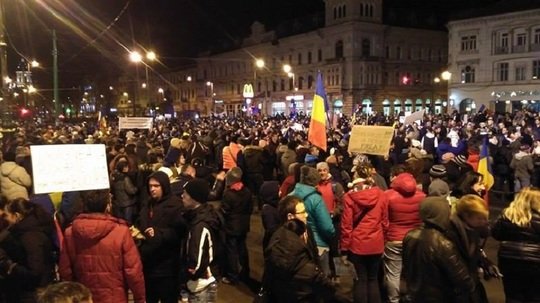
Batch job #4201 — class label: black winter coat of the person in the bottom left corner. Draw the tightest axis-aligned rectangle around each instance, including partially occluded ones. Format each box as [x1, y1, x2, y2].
[0, 205, 55, 303]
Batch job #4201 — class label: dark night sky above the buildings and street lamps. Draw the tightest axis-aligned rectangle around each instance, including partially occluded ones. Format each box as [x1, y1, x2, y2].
[2, 0, 516, 94]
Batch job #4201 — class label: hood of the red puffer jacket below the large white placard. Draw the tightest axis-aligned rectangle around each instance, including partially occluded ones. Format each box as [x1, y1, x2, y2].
[72, 213, 126, 240]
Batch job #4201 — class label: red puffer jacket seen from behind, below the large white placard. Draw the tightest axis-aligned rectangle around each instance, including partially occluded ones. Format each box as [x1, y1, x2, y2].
[59, 213, 146, 303]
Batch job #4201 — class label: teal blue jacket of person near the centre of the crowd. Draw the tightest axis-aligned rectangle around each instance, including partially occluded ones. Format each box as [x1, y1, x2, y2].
[289, 183, 336, 247]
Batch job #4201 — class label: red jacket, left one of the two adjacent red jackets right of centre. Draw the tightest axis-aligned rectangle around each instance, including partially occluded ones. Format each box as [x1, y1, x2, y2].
[341, 187, 387, 255]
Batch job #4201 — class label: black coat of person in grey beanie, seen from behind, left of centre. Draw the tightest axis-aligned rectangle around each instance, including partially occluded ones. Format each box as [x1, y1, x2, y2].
[221, 183, 253, 236]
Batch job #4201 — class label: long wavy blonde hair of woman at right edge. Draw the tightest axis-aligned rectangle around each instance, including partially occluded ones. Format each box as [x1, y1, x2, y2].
[502, 188, 540, 227]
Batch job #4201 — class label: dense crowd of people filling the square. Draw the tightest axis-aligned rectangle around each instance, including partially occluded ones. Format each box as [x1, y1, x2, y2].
[0, 111, 540, 303]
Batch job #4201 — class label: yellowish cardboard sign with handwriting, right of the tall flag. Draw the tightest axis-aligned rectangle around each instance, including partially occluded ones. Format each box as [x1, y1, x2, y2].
[349, 125, 394, 156]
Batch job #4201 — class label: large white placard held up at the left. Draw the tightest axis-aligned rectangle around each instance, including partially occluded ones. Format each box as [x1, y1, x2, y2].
[30, 144, 109, 194]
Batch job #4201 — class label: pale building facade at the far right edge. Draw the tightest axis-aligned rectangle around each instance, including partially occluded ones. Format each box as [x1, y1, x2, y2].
[448, 9, 540, 112]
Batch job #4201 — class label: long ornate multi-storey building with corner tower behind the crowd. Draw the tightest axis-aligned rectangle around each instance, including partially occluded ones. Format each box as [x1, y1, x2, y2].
[144, 0, 448, 115]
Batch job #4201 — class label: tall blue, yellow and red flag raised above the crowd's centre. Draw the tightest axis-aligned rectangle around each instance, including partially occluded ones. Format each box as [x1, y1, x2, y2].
[308, 72, 327, 151]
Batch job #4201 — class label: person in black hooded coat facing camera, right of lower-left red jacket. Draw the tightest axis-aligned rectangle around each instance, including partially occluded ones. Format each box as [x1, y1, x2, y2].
[139, 171, 186, 303]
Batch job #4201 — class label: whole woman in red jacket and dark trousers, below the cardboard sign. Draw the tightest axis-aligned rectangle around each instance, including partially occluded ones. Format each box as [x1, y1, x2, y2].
[341, 164, 388, 303]
